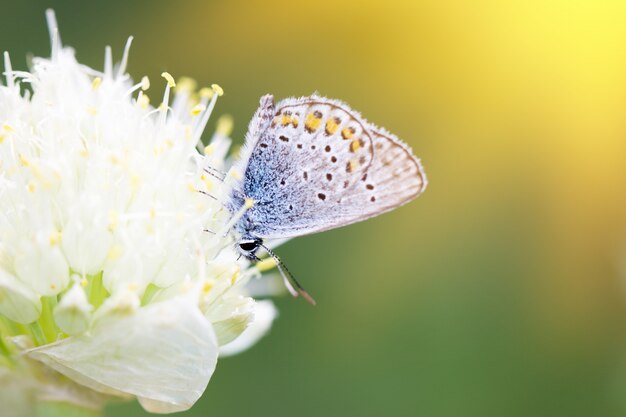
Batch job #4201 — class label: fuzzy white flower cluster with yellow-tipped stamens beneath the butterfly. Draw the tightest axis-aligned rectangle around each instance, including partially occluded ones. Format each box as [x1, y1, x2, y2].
[0, 12, 275, 415]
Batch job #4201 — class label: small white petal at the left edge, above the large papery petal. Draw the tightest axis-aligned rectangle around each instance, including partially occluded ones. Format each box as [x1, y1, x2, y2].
[0, 268, 41, 324]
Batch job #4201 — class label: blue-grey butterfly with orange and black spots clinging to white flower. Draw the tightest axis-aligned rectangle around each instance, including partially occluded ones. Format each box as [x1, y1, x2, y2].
[228, 95, 427, 304]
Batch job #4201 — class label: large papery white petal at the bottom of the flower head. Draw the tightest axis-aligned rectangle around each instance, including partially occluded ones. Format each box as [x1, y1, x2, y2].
[29, 297, 217, 412]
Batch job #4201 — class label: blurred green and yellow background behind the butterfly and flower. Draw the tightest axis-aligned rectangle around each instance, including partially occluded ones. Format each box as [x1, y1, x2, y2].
[0, 0, 626, 417]
